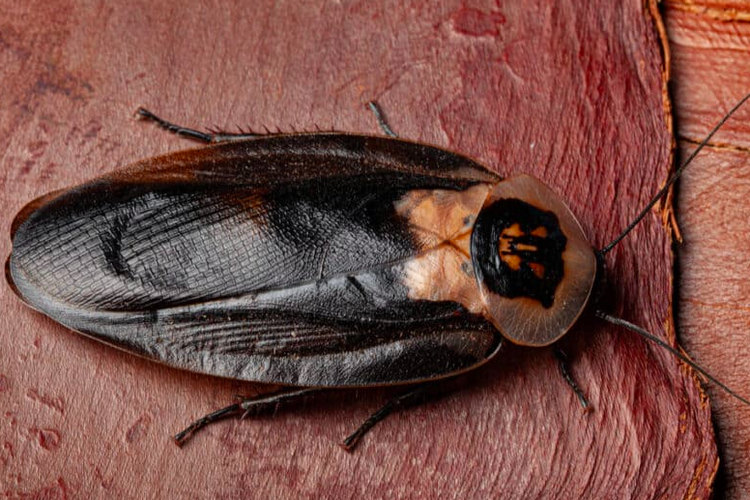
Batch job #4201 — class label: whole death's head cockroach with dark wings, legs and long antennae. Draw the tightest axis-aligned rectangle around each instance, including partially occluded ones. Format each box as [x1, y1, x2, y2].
[6, 96, 750, 449]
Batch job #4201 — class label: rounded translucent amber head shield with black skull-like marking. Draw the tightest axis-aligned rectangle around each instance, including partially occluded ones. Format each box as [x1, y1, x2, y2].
[471, 175, 596, 346]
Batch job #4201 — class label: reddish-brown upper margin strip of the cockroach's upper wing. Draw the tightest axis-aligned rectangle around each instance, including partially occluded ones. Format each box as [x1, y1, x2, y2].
[105, 133, 501, 187]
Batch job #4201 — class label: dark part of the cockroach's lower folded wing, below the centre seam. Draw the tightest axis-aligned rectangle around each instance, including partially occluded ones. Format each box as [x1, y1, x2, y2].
[19, 265, 501, 387]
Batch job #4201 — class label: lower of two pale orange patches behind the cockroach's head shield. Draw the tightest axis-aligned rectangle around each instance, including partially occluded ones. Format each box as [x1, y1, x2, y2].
[404, 243, 484, 314]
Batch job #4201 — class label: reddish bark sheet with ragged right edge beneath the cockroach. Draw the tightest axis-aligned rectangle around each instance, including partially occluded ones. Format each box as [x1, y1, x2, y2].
[0, 0, 729, 498]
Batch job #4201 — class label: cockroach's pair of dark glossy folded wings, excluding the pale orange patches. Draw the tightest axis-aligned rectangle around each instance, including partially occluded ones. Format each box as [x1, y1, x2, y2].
[9, 135, 506, 386]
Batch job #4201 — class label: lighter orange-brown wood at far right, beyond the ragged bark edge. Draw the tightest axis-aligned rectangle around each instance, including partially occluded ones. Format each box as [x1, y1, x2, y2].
[666, 0, 750, 499]
